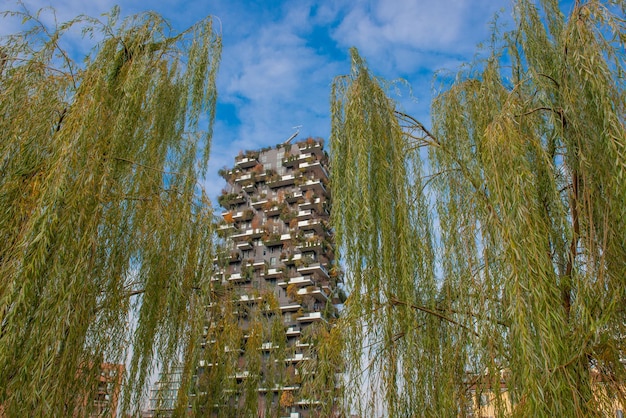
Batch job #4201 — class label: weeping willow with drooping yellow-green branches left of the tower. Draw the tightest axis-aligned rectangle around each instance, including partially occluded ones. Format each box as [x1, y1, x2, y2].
[0, 4, 221, 416]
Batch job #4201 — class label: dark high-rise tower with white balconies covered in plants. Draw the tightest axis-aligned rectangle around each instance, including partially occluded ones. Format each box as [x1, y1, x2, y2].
[198, 138, 342, 418]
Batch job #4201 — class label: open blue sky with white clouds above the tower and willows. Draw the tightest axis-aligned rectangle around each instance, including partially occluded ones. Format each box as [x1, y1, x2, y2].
[0, 0, 524, 202]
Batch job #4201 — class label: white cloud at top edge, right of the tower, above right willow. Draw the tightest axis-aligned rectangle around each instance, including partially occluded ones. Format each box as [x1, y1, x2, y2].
[333, 0, 503, 72]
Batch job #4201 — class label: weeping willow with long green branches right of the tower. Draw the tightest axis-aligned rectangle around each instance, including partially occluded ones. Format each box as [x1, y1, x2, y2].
[331, 0, 626, 417]
